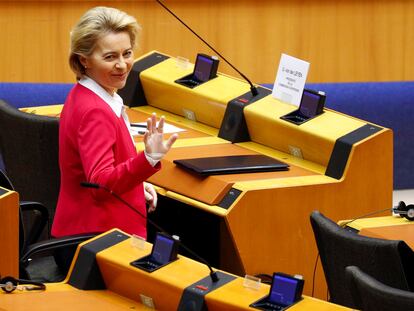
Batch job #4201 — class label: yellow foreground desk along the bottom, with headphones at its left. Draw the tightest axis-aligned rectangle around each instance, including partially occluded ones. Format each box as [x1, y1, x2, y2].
[0, 230, 350, 311]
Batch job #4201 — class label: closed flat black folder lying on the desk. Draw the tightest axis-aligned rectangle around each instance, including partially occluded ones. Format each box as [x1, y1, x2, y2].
[173, 154, 289, 176]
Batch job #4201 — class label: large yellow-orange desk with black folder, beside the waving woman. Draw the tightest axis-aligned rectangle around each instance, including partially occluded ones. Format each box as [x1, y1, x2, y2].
[27, 52, 393, 297]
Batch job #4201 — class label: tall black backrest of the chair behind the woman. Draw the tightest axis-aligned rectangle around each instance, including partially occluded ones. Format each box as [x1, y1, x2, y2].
[0, 100, 60, 236]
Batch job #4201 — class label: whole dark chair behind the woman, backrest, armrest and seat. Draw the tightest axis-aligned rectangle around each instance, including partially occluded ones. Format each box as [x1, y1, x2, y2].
[0, 100, 95, 282]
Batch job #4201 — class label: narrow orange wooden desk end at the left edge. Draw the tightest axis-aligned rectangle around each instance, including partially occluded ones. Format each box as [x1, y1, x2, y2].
[0, 187, 19, 277]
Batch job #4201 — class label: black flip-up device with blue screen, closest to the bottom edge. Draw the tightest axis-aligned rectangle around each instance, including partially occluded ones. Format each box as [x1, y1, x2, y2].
[250, 272, 304, 310]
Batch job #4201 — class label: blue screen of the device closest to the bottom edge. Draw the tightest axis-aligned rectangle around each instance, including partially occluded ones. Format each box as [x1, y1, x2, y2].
[269, 273, 300, 306]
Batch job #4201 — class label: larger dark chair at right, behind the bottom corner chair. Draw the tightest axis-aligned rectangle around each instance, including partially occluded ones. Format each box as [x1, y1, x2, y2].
[310, 211, 414, 308]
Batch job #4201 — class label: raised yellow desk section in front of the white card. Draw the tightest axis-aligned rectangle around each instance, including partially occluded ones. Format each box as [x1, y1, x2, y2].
[244, 96, 378, 166]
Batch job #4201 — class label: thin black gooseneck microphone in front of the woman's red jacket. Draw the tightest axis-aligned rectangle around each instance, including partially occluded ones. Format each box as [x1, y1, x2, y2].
[80, 181, 219, 283]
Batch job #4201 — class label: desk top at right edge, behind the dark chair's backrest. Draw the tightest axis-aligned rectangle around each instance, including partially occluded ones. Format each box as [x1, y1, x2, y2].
[342, 216, 414, 250]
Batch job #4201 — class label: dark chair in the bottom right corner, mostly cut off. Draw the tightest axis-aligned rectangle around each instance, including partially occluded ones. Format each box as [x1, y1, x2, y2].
[345, 266, 414, 311]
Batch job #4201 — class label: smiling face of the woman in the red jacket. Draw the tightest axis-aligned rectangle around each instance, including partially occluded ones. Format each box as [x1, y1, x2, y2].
[80, 32, 134, 95]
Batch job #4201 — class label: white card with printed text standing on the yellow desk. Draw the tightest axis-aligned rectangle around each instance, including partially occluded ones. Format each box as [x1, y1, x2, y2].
[272, 53, 310, 106]
